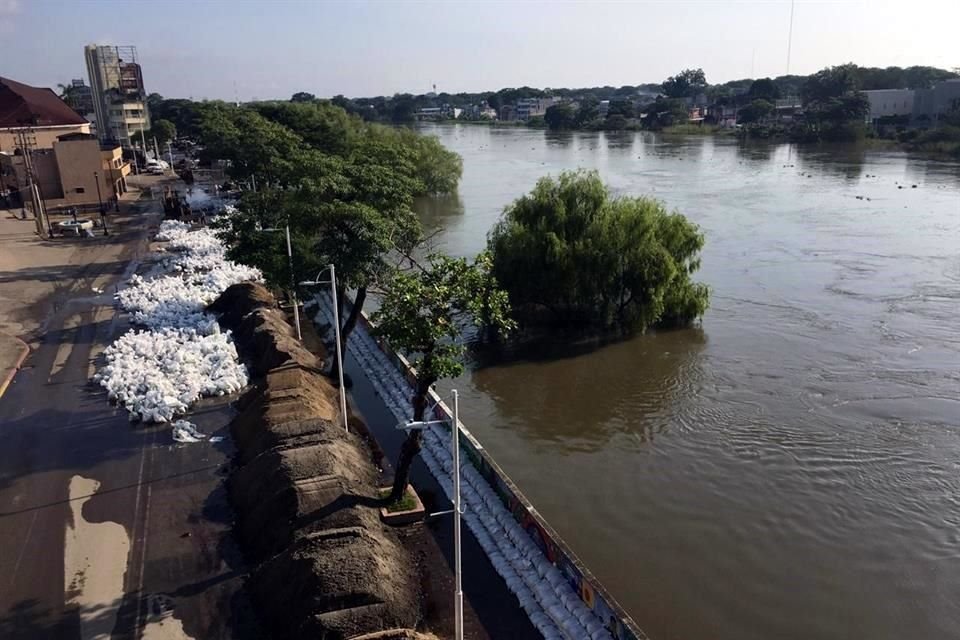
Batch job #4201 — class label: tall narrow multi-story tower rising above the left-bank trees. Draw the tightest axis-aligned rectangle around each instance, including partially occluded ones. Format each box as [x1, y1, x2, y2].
[84, 44, 150, 147]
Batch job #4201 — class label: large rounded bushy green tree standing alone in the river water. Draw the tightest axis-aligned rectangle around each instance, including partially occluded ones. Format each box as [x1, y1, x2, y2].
[488, 171, 709, 332]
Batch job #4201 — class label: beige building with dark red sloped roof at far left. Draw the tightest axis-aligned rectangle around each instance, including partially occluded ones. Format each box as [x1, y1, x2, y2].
[0, 78, 130, 207]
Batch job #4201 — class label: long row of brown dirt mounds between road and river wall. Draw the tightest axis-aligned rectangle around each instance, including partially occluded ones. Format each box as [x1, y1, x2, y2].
[210, 283, 420, 640]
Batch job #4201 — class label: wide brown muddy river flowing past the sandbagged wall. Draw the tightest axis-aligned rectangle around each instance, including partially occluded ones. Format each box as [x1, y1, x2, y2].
[420, 126, 960, 640]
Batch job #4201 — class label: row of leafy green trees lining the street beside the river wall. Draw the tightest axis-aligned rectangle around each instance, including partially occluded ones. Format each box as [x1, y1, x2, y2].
[150, 96, 513, 502]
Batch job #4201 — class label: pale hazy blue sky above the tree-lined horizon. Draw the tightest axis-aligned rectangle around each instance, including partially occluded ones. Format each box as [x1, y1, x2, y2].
[0, 0, 960, 100]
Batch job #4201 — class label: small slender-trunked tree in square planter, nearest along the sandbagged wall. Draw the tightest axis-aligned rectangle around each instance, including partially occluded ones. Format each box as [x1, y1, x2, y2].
[373, 254, 514, 501]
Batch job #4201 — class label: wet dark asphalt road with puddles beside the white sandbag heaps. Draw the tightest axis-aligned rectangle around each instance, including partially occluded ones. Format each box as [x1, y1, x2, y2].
[0, 208, 262, 640]
